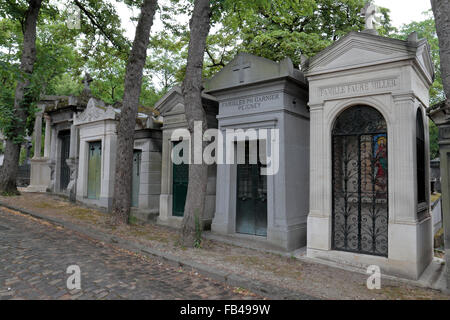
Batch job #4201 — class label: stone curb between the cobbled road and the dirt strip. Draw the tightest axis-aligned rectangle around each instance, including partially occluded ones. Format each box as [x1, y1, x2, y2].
[0, 201, 318, 300]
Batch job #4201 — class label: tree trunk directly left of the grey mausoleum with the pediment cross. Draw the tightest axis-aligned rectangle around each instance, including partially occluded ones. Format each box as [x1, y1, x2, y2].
[180, 0, 211, 247]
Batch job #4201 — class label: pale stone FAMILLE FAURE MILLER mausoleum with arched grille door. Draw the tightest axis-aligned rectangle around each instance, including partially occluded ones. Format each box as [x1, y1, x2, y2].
[305, 30, 434, 278]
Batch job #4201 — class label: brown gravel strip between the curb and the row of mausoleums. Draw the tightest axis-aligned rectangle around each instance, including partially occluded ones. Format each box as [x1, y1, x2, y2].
[0, 193, 450, 300]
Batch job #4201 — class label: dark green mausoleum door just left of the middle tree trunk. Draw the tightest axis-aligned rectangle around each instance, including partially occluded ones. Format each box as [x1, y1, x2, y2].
[172, 142, 189, 217]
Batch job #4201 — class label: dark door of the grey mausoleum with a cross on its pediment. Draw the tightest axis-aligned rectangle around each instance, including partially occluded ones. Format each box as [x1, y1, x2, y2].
[236, 142, 267, 236]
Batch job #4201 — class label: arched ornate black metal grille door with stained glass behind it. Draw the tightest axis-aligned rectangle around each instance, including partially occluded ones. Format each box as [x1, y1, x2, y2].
[332, 106, 389, 256]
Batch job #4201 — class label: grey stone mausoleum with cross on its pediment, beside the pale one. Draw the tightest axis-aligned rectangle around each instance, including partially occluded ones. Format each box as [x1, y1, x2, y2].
[206, 53, 309, 250]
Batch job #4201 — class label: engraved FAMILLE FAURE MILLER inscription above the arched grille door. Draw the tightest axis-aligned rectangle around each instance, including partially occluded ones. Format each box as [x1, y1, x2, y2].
[319, 78, 399, 97]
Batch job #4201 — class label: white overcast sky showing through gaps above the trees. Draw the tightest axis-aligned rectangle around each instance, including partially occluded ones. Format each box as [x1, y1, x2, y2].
[115, 0, 431, 40]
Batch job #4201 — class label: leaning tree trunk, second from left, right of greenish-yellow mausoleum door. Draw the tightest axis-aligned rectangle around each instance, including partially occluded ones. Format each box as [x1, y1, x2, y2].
[112, 0, 158, 223]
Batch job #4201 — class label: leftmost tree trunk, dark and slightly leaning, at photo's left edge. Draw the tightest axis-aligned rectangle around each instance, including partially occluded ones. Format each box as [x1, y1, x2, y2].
[0, 0, 42, 194]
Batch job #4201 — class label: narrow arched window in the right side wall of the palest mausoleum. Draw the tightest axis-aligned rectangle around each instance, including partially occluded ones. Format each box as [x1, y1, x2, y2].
[416, 109, 426, 203]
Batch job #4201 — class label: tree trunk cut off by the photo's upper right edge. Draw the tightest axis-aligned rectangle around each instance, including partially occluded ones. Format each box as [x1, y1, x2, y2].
[431, 0, 450, 108]
